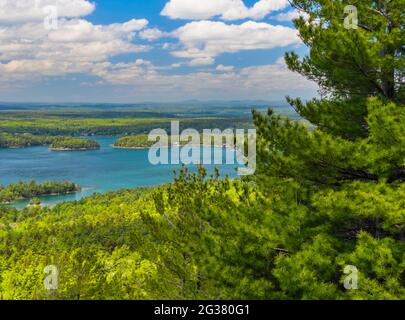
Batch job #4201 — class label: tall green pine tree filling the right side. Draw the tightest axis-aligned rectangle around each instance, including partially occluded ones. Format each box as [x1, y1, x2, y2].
[249, 0, 405, 299]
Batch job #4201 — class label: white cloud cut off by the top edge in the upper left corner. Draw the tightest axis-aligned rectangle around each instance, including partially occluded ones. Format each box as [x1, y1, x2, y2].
[0, 0, 95, 24]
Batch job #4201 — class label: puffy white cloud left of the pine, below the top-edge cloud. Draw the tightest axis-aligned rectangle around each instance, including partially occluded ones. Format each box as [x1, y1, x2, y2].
[172, 21, 301, 65]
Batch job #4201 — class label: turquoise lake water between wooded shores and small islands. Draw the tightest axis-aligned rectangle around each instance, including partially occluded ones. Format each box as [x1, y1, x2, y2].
[0, 137, 237, 208]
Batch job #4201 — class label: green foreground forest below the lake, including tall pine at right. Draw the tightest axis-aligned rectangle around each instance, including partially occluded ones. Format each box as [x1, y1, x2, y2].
[0, 0, 405, 299]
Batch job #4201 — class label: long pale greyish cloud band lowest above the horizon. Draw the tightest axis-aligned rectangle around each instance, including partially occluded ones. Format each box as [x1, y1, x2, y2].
[0, 52, 317, 101]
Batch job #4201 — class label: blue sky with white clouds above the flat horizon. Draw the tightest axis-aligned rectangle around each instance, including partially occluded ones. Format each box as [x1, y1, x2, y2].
[0, 0, 316, 102]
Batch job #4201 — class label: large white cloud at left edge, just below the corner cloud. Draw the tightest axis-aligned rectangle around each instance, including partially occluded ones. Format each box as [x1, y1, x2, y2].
[0, 19, 148, 64]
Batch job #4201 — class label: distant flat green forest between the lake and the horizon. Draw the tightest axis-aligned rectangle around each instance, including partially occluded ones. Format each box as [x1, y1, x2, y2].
[0, 109, 253, 149]
